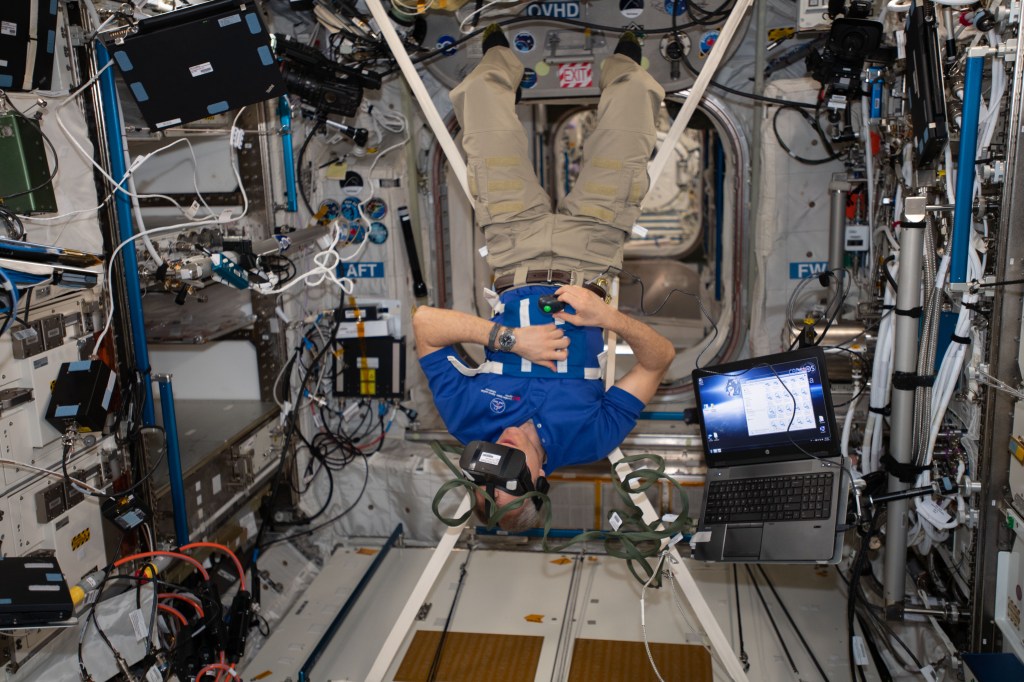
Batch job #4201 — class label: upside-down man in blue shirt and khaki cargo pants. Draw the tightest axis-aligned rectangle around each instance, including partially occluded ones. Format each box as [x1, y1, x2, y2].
[413, 29, 676, 530]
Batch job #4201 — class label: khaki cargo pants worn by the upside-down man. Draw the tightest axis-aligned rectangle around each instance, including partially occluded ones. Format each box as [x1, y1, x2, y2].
[451, 47, 665, 284]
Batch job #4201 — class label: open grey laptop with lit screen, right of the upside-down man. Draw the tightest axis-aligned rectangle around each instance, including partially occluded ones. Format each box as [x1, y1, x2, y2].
[691, 346, 849, 563]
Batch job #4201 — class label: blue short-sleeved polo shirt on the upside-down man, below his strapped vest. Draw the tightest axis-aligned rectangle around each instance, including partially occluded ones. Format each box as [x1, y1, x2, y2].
[420, 288, 644, 474]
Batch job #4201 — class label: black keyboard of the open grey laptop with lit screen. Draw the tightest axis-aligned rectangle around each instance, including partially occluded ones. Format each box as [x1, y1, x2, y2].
[705, 472, 833, 524]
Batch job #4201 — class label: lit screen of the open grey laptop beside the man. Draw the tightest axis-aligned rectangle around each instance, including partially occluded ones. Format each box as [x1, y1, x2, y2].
[693, 347, 839, 458]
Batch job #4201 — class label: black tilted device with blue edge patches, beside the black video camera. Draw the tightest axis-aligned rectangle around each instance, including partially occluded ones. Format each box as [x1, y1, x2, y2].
[108, 0, 285, 131]
